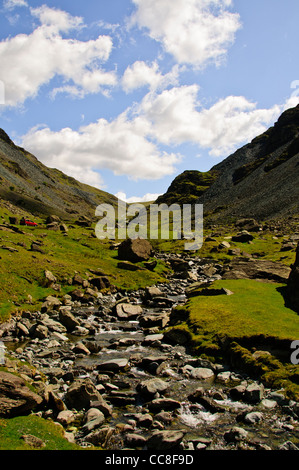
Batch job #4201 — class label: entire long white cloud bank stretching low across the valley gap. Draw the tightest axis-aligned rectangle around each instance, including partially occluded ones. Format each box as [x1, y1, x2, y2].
[22, 81, 282, 190]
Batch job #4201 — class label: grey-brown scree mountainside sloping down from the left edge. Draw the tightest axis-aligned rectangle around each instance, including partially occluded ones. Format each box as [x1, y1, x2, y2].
[0, 129, 117, 220]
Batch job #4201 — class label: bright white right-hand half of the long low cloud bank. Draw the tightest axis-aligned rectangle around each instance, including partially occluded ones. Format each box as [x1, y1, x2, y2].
[139, 85, 282, 157]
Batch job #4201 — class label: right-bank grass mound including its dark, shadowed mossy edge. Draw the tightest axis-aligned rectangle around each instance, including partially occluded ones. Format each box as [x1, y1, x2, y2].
[172, 279, 299, 400]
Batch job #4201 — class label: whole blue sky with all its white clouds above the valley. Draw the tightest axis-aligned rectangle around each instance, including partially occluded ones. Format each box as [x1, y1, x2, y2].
[0, 0, 299, 201]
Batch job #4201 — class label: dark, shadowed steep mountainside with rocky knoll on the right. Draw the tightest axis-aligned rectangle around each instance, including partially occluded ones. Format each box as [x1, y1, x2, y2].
[157, 105, 299, 221]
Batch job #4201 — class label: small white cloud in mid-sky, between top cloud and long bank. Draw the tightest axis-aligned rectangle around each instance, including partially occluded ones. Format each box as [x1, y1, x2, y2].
[122, 61, 179, 93]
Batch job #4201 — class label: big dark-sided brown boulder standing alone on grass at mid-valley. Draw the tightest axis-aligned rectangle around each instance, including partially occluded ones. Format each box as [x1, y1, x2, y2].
[118, 238, 153, 263]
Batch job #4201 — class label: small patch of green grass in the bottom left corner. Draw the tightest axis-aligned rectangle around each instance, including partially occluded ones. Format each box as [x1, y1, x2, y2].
[0, 415, 81, 451]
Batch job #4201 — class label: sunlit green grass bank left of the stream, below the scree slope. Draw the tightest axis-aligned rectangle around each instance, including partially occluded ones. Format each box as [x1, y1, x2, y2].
[0, 218, 167, 322]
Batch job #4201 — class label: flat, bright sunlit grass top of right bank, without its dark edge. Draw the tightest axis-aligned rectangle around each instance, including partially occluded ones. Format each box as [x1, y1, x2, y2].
[187, 279, 299, 339]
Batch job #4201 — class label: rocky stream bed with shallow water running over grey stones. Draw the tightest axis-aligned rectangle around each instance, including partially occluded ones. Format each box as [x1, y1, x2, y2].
[1, 253, 299, 451]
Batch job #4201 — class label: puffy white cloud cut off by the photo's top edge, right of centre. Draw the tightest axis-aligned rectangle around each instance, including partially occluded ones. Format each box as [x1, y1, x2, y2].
[131, 0, 241, 67]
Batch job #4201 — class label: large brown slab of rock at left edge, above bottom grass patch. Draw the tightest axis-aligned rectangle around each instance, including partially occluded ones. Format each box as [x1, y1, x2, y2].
[0, 371, 43, 418]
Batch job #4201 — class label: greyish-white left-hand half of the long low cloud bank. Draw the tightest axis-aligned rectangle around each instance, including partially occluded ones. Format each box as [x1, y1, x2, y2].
[22, 113, 180, 186]
